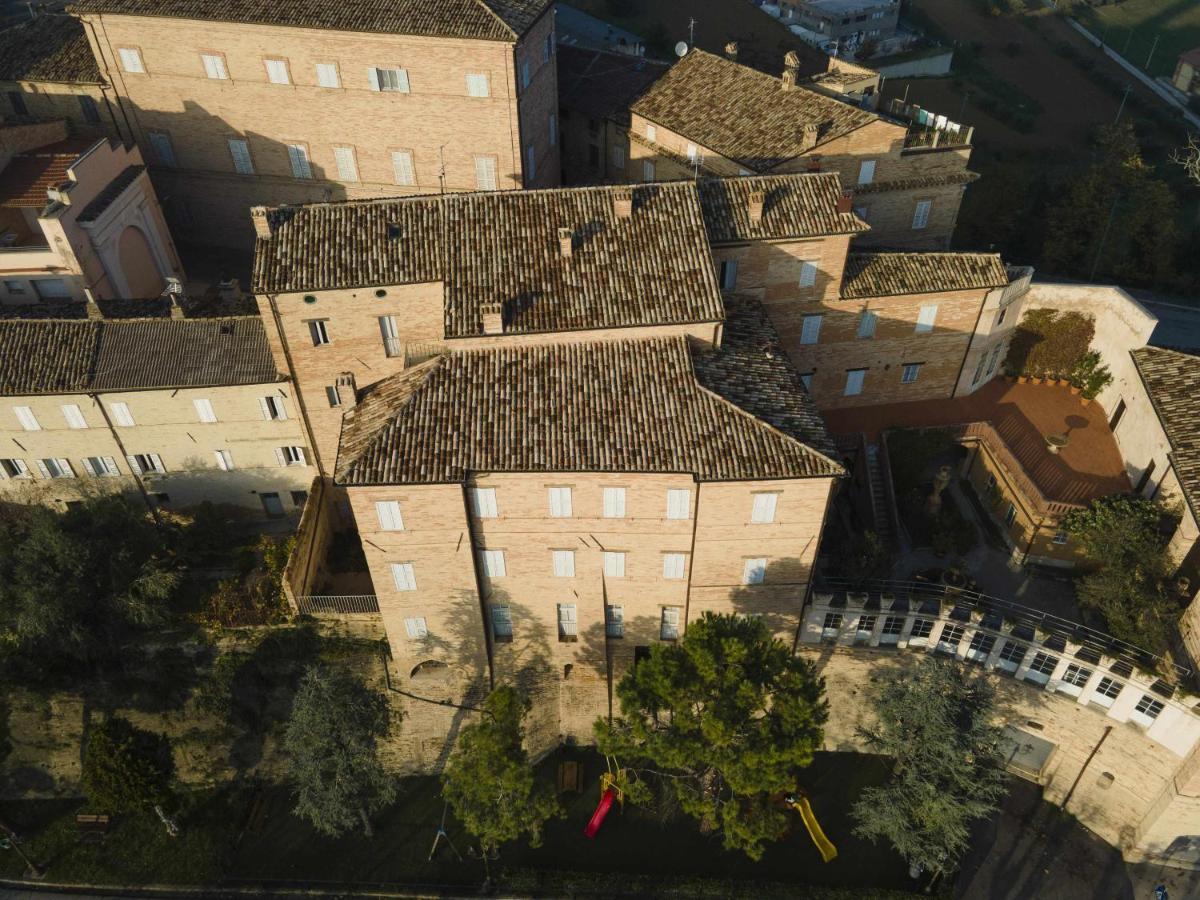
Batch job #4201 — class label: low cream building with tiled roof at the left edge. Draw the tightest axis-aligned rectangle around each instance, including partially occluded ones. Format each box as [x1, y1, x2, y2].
[0, 316, 314, 516]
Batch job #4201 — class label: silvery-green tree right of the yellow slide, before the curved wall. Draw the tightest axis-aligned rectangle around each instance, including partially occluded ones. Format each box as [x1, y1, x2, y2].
[851, 656, 1006, 872]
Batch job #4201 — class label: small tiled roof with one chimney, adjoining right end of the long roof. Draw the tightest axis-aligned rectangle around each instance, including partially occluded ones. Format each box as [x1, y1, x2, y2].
[700, 172, 870, 244]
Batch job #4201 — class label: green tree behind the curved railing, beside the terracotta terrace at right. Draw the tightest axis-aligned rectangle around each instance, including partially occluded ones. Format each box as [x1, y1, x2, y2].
[1063, 494, 1178, 654]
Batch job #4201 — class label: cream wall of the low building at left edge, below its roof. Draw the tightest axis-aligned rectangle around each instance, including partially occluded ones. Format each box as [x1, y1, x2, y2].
[0, 384, 314, 512]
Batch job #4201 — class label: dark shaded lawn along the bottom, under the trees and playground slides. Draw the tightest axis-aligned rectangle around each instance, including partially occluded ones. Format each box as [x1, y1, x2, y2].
[0, 751, 910, 898]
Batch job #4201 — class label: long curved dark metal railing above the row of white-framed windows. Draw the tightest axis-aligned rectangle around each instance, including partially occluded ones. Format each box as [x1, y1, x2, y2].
[814, 576, 1192, 680]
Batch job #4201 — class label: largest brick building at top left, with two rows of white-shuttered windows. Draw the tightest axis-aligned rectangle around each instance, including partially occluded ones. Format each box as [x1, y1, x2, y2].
[72, 0, 559, 246]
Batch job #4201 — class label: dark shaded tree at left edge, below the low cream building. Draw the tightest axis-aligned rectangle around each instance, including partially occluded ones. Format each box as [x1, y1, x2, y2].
[0, 496, 179, 676]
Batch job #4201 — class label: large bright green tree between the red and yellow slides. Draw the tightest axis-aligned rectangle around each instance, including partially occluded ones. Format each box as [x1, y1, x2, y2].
[595, 613, 828, 859]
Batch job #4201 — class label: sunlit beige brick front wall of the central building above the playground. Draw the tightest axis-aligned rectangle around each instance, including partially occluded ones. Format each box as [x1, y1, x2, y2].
[348, 473, 832, 763]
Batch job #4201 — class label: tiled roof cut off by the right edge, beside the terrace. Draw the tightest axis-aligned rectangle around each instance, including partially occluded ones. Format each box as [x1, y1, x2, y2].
[1132, 347, 1200, 528]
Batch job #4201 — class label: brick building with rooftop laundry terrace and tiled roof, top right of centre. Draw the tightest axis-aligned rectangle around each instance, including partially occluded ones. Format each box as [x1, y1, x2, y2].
[625, 50, 976, 250]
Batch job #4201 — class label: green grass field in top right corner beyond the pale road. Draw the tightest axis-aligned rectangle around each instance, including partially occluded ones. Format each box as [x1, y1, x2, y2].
[1072, 0, 1200, 77]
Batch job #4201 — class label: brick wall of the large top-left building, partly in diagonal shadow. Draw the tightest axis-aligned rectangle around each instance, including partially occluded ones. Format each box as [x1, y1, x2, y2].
[84, 16, 557, 245]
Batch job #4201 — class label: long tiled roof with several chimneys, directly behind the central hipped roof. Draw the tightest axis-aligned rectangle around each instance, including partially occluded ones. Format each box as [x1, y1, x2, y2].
[252, 181, 721, 337]
